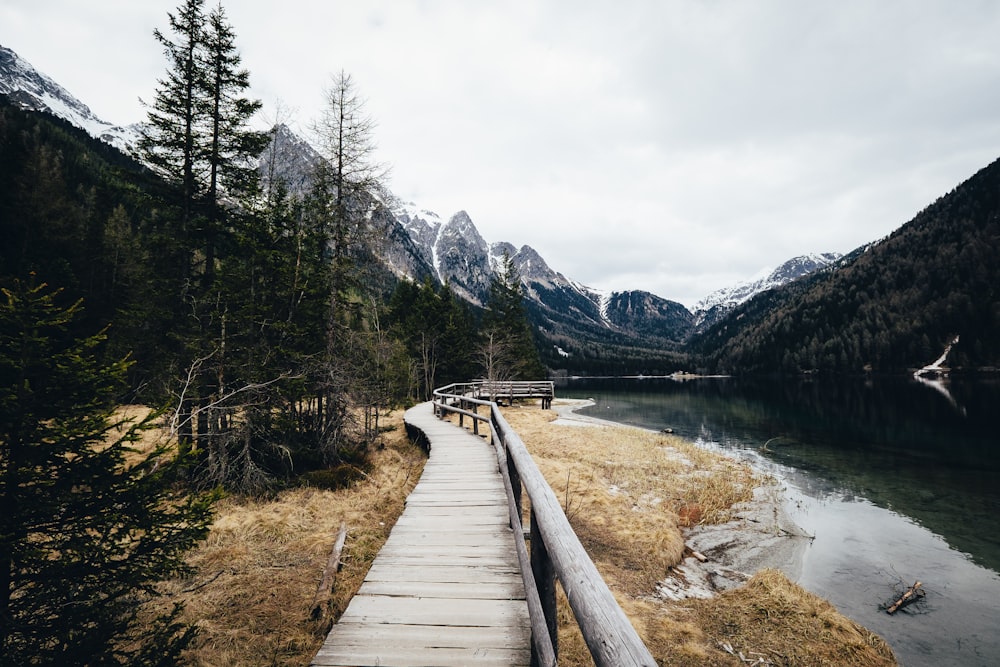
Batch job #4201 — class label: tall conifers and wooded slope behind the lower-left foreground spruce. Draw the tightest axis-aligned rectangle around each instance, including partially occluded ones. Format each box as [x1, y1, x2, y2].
[0, 0, 544, 493]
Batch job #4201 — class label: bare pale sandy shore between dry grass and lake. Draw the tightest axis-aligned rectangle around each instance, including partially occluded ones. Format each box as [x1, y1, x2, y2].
[551, 398, 812, 600]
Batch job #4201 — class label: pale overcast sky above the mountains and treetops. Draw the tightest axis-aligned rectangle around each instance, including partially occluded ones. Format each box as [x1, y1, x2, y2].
[0, 0, 1000, 306]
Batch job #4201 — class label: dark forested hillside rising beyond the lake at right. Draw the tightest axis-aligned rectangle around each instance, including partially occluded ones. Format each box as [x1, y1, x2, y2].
[691, 161, 1000, 373]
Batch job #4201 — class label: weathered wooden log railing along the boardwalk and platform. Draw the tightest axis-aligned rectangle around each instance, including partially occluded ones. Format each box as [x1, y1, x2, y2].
[434, 382, 656, 667]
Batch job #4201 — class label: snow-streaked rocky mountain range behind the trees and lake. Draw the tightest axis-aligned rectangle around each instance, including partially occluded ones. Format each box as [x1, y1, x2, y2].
[0, 47, 860, 371]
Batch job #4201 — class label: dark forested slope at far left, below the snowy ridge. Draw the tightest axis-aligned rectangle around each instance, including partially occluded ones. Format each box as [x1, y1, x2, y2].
[0, 97, 175, 384]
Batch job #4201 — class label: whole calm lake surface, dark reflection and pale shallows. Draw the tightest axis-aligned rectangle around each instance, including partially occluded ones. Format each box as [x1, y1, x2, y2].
[556, 378, 1000, 667]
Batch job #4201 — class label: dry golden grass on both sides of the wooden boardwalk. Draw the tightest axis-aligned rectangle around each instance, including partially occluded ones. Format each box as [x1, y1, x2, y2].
[145, 407, 895, 667]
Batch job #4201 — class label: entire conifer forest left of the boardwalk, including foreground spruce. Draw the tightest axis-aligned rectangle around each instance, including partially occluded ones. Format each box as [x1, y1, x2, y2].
[0, 0, 544, 665]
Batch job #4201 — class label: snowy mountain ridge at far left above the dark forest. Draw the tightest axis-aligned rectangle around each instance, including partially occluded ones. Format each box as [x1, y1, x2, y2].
[0, 46, 139, 153]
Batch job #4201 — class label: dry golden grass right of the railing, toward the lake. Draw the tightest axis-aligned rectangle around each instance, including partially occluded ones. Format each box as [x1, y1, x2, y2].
[504, 407, 896, 666]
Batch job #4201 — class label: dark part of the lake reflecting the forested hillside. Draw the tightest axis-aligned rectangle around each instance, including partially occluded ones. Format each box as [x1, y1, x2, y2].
[557, 377, 1000, 571]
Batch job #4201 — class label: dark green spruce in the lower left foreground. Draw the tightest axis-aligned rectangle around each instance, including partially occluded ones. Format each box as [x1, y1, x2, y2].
[0, 282, 211, 665]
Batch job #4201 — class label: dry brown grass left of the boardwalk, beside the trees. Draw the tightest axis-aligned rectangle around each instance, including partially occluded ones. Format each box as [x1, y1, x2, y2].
[146, 412, 425, 667]
